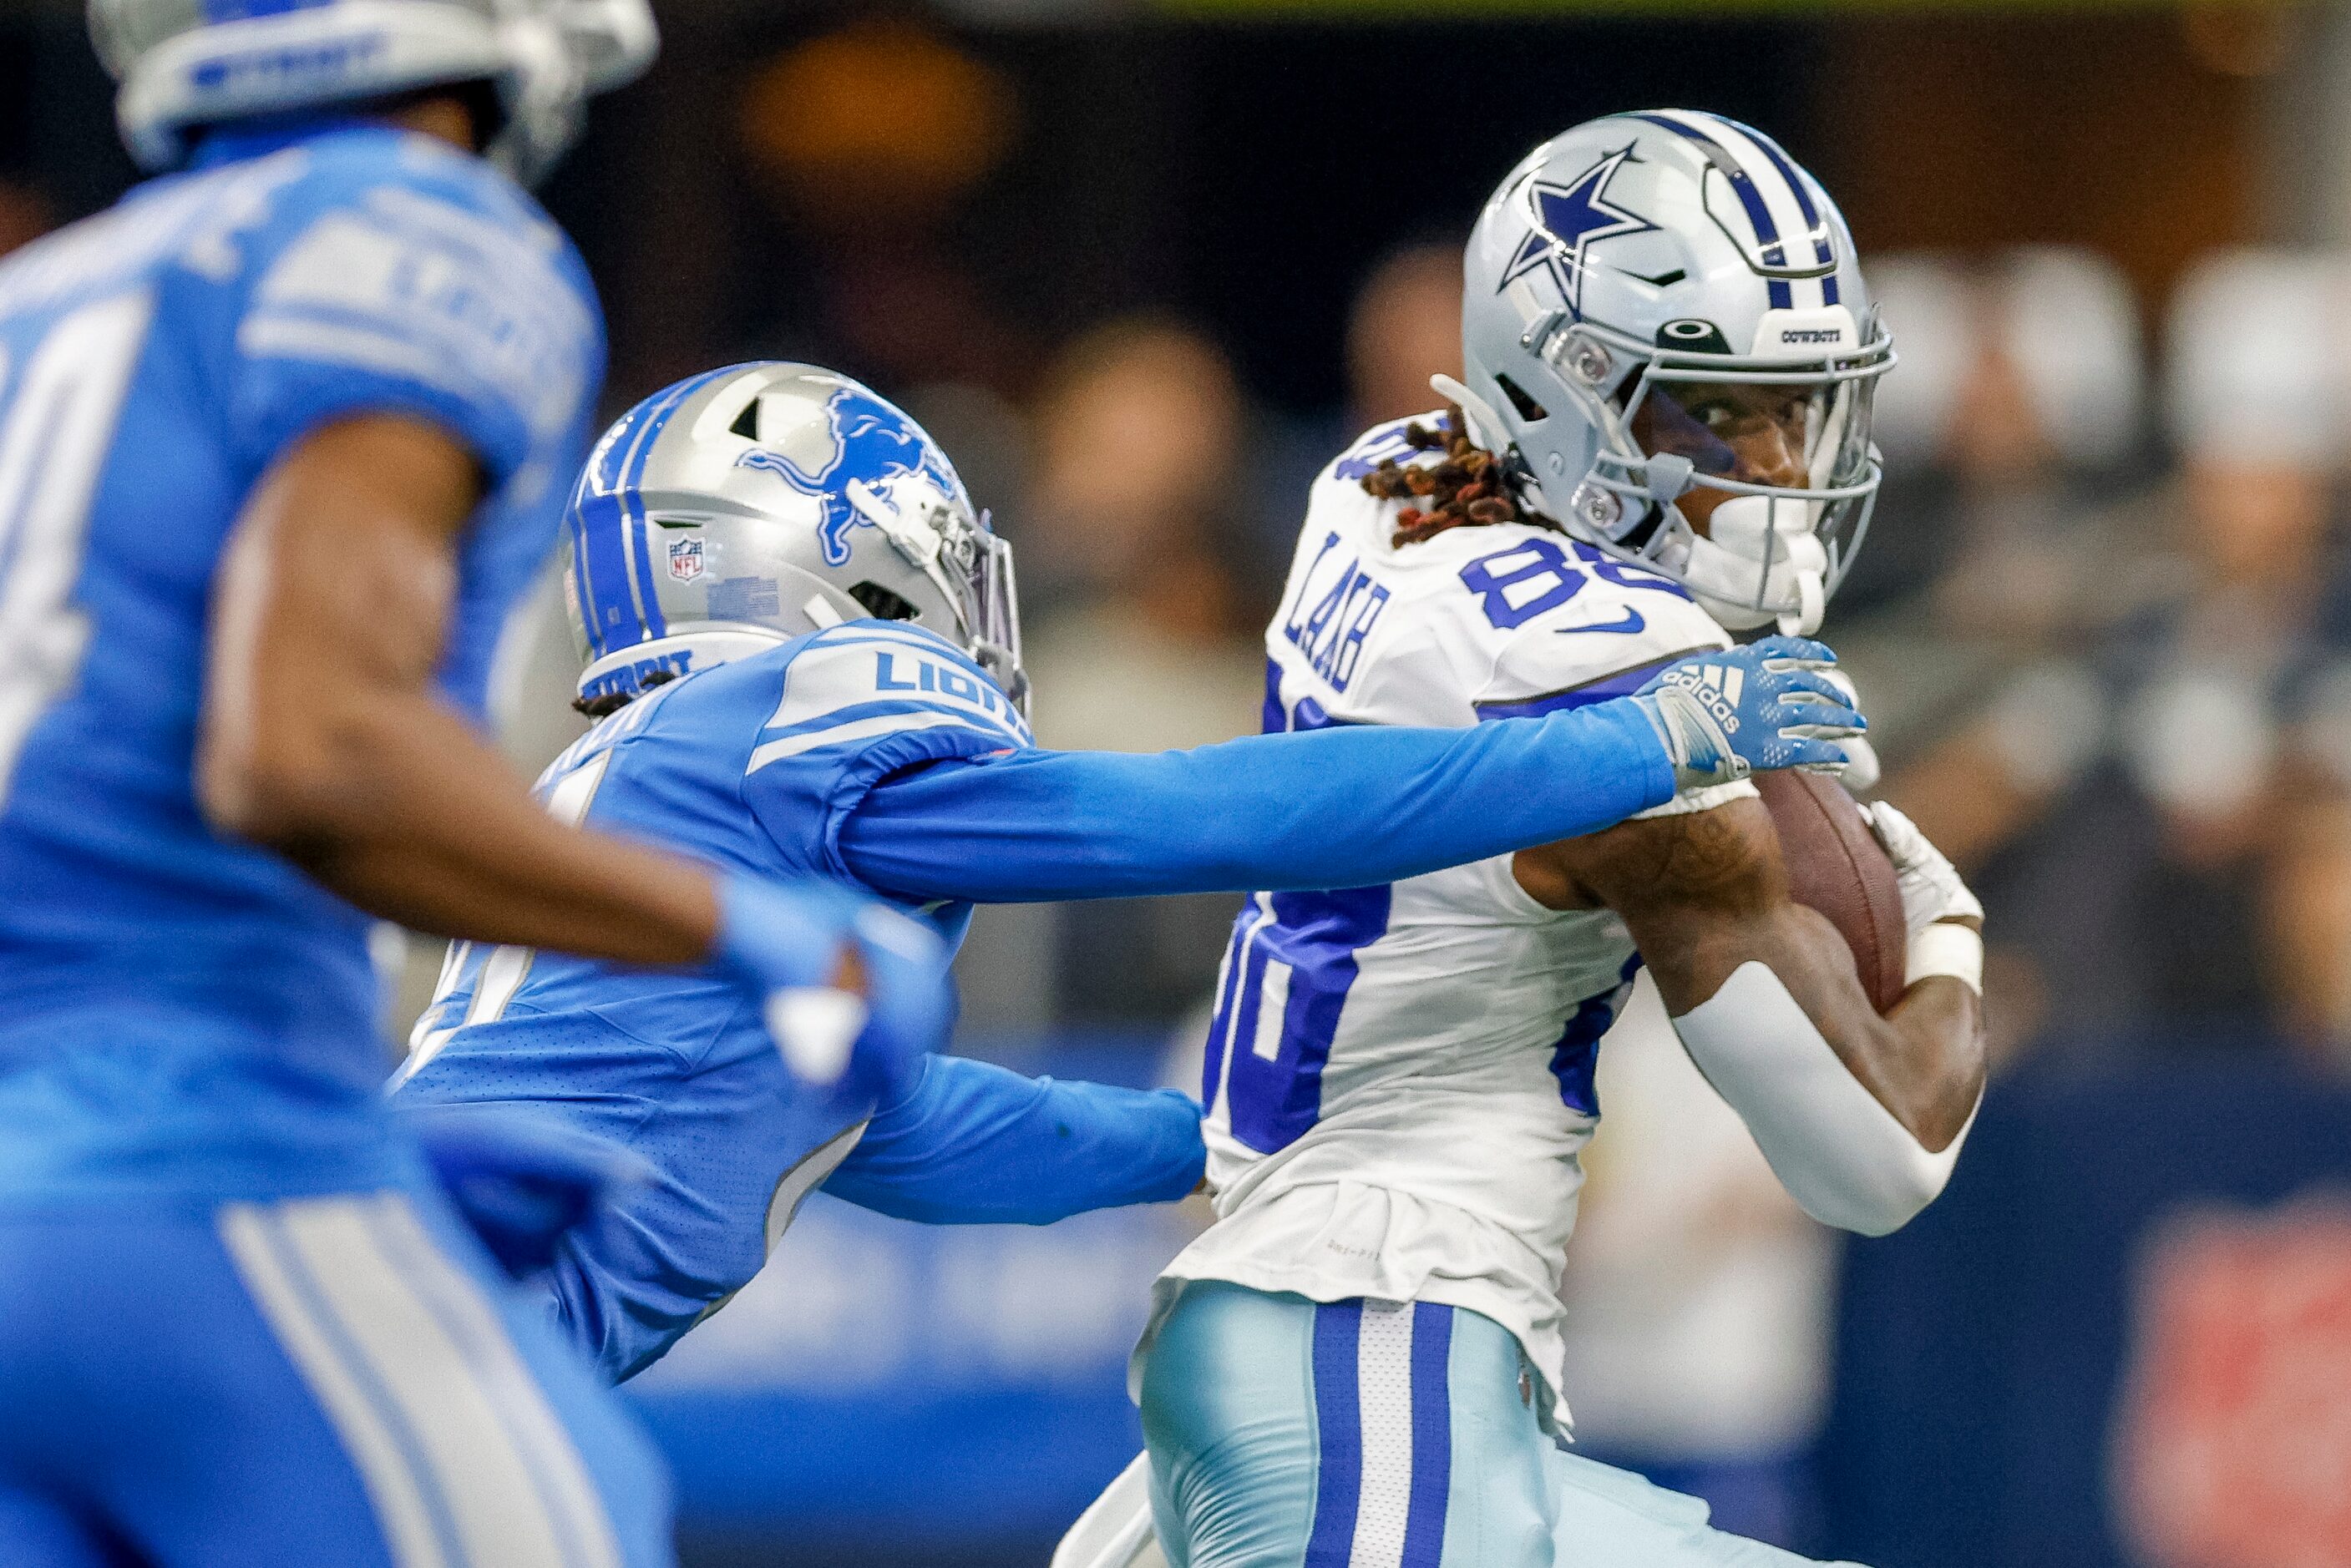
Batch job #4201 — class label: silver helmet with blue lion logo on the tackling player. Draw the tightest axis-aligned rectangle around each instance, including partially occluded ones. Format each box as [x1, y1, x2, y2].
[565, 362, 1027, 710]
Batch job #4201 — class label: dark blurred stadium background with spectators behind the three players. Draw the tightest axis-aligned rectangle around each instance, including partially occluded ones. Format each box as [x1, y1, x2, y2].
[13, 0, 2351, 1568]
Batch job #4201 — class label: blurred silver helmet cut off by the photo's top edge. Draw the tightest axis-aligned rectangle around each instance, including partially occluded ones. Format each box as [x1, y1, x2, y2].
[89, 0, 658, 181]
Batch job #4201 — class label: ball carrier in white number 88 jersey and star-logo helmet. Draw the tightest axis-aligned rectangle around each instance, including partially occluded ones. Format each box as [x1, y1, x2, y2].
[1062, 110, 1982, 1568]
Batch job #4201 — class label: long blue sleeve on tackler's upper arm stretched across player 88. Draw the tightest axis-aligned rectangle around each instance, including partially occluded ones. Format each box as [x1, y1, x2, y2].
[839, 701, 1674, 903]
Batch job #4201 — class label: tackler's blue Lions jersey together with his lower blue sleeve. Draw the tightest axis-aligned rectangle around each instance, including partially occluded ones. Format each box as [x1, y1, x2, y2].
[398, 620, 1203, 1378]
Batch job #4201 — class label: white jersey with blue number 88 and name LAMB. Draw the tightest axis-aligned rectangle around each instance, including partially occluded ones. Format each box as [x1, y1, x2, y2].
[1145, 416, 1751, 1427]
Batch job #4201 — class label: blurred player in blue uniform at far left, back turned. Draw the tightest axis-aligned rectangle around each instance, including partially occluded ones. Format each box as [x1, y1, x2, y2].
[0, 0, 947, 1568]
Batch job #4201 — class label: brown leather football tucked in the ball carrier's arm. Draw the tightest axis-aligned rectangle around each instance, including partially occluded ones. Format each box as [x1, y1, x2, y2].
[1756, 769, 1909, 1014]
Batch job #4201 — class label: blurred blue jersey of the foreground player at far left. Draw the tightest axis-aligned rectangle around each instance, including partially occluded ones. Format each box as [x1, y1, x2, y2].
[0, 122, 604, 1201]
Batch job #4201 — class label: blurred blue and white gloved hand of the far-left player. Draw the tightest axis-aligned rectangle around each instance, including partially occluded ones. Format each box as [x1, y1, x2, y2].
[712, 874, 955, 1103]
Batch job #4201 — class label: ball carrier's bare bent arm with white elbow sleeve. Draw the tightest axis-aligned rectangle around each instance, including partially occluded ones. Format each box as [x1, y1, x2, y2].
[1517, 799, 1984, 1234]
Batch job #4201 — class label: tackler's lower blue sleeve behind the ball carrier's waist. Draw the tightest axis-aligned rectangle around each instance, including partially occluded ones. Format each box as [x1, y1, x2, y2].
[825, 1055, 1208, 1225]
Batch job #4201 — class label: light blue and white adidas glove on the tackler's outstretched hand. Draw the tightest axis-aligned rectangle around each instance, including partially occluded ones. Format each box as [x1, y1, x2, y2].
[1634, 637, 1869, 790]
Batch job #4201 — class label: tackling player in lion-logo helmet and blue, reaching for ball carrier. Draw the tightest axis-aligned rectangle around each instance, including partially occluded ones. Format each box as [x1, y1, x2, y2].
[395, 364, 1860, 1378]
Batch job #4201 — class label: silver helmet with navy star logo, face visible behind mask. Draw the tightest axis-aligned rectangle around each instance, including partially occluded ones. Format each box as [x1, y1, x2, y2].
[1439, 109, 1895, 632]
